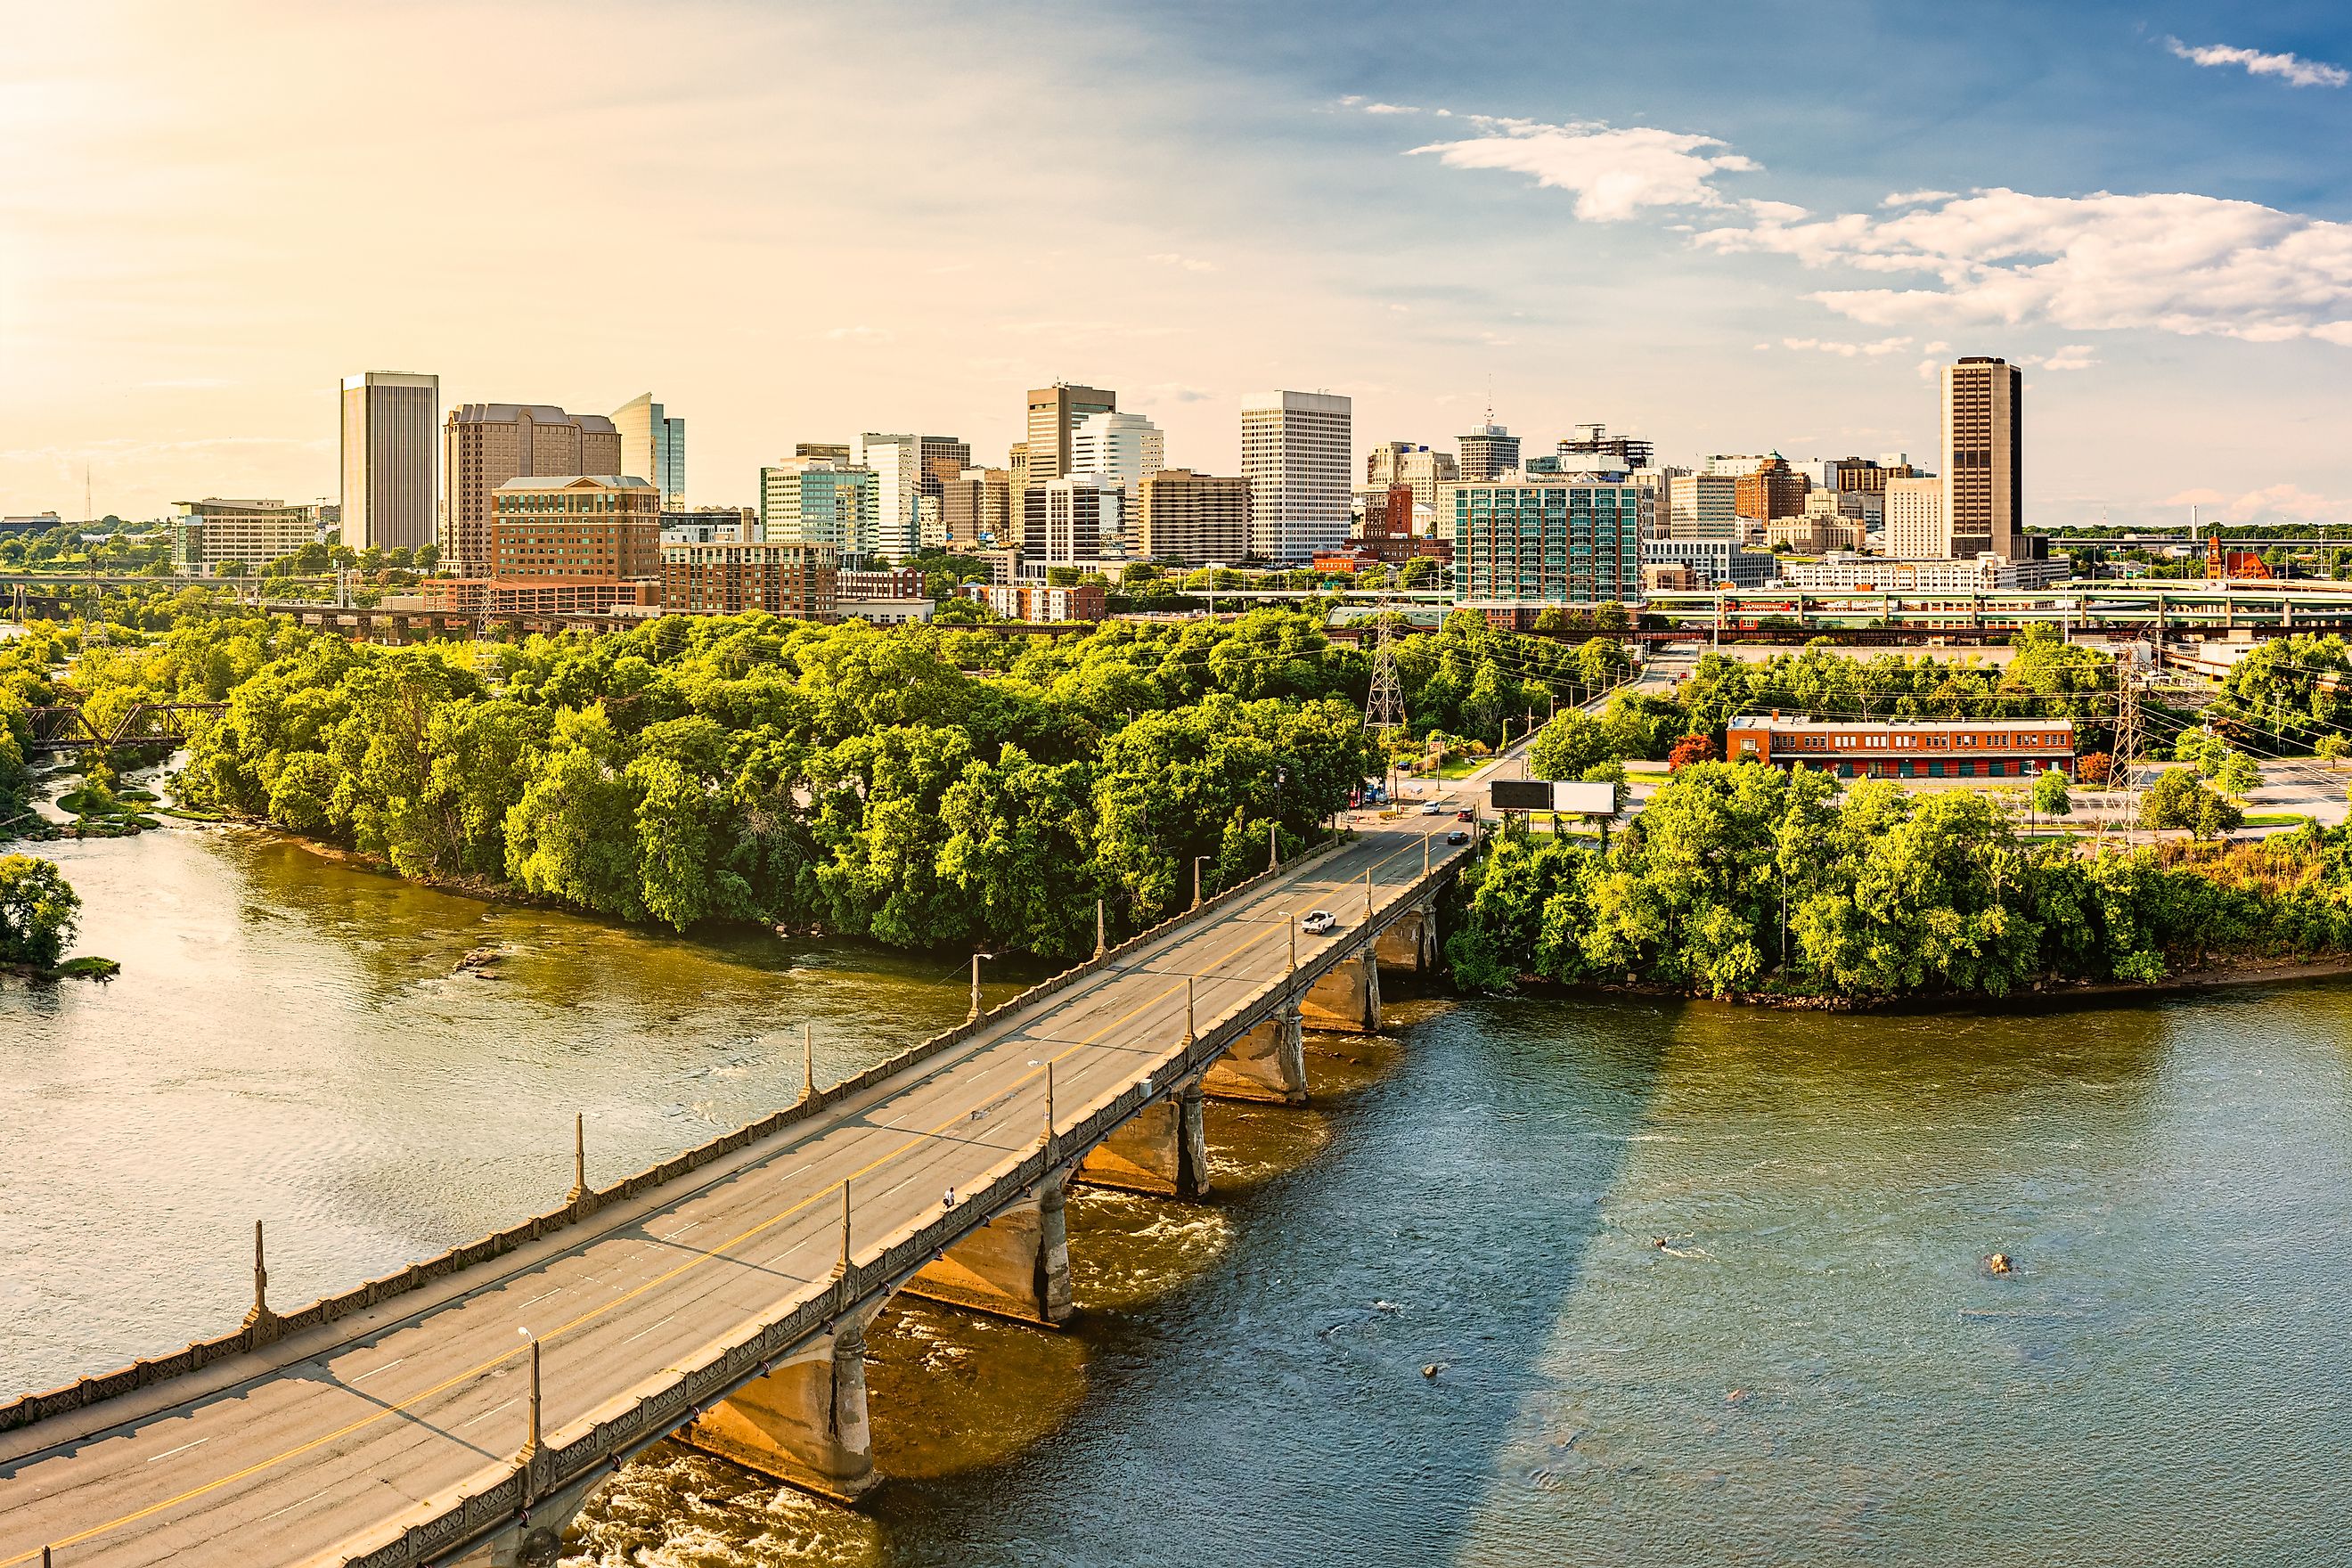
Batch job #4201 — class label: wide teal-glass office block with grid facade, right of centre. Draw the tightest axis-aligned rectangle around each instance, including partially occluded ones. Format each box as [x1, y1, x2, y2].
[1447, 479, 1644, 611]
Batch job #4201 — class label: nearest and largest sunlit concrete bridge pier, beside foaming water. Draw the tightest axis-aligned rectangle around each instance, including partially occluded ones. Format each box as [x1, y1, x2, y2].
[677, 1311, 879, 1502]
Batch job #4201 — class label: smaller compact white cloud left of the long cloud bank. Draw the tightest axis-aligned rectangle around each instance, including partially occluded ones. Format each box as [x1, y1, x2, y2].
[1409, 115, 1760, 224]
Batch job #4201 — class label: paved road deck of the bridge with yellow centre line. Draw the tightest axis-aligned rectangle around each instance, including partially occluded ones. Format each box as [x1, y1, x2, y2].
[0, 829, 1458, 1568]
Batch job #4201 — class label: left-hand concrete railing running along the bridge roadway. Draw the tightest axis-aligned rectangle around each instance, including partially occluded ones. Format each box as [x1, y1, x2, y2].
[0, 839, 1341, 1432]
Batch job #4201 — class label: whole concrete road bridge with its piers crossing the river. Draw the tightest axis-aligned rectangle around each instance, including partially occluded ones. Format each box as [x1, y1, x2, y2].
[0, 829, 1467, 1568]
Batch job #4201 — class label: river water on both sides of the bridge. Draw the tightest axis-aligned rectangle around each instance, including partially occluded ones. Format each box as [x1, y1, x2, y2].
[0, 828, 2352, 1568]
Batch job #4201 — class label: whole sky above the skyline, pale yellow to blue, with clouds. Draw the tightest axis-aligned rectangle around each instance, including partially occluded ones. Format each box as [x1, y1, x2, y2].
[0, 0, 2352, 524]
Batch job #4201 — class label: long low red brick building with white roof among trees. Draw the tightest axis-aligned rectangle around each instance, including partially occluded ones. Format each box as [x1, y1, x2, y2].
[1724, 713, 2074, 778]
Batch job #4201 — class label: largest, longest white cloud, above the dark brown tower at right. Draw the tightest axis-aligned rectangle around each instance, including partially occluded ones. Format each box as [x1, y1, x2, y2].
[1694, 188, 2352, 346]
